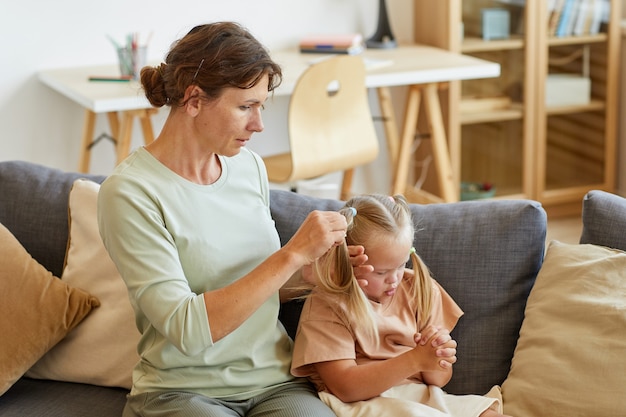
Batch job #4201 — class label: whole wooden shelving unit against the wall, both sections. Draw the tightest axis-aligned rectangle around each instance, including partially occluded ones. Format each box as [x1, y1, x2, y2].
[414, 0, 621, 213]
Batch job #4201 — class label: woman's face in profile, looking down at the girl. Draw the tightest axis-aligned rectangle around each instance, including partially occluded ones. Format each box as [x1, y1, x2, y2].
[196, 75, 268, 156]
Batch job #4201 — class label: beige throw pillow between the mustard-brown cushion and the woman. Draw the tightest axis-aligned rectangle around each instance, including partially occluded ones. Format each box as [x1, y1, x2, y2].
[27, 179, 139, 388]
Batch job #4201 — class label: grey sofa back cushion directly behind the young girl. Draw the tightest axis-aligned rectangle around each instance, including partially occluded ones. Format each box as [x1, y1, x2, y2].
[270, 190, 546, 394]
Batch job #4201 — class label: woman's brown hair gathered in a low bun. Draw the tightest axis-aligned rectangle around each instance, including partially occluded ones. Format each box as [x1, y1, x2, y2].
[141, 22, 282, 107]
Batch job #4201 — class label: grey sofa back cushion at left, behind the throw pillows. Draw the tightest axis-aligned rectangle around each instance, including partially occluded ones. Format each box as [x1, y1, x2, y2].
[0, 161, 104, 277]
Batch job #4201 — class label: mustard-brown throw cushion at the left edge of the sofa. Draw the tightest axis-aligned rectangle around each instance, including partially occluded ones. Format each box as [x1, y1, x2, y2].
[0, 224, 99, 395]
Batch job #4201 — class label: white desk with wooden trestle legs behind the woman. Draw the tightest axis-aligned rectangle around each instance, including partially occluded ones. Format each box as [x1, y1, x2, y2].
[39, 45, 500, 201]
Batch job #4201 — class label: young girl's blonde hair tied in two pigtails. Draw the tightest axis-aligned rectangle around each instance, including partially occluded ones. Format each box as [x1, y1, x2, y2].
[313, 194, 432, 342]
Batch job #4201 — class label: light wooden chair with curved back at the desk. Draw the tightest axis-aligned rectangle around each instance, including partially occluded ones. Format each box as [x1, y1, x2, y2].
[263, 55, 378, 200]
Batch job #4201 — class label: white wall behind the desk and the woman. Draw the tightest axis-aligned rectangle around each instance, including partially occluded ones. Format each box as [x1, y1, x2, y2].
[0, 0, 412, 195]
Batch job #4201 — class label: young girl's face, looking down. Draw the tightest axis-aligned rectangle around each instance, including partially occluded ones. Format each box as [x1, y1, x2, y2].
[359, 237, 412, 303]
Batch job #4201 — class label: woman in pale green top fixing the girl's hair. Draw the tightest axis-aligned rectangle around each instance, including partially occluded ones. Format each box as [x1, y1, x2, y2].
[98, 22, 348, 417]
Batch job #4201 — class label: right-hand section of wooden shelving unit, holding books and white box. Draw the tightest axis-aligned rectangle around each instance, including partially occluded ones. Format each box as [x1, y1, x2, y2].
[535, 4, 622, 213]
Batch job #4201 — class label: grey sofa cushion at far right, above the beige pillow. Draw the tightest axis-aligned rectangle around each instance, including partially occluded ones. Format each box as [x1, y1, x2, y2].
[580, 190, 626, 250]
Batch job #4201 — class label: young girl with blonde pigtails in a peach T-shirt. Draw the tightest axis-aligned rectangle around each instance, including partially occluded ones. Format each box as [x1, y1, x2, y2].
[291, 195, 502, 417]
